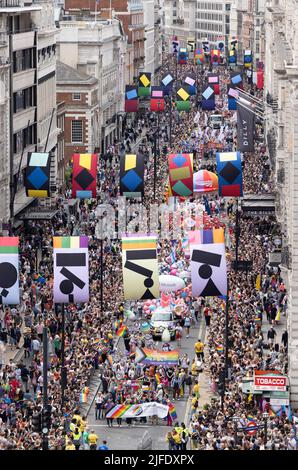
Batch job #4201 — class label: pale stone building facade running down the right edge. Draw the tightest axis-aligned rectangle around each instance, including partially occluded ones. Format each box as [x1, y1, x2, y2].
[265, 0, 298, 407]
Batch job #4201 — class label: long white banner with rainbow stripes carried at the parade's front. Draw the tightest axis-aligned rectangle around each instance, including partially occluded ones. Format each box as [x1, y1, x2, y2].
[106, 401, 169, 419]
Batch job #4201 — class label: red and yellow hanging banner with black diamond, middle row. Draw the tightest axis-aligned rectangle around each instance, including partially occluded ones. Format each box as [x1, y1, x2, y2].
[72, 153, 97, 199]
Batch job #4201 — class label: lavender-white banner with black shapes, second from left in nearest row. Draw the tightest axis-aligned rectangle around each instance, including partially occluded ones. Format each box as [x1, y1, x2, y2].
[53, 236, 89, 304]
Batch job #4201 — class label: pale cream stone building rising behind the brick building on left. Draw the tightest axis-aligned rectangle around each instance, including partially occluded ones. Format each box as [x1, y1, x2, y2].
[58, 16, 126, 151]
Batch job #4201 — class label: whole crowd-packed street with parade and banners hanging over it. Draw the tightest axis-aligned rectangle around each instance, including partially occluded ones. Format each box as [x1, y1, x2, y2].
[0, 0, 298, 453]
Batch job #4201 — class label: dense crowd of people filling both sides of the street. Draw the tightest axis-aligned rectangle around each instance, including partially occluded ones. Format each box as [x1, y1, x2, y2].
[0, 49, 296, 450]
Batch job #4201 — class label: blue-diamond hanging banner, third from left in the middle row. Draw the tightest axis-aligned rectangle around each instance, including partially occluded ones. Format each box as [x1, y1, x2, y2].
[120, 153, 144, 197]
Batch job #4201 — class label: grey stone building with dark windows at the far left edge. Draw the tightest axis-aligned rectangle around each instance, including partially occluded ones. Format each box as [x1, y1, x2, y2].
[0, 0, 57, 221]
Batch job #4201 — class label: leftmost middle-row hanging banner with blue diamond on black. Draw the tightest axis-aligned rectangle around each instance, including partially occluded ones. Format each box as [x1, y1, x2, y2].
[25, 152, 51, 197]
